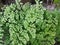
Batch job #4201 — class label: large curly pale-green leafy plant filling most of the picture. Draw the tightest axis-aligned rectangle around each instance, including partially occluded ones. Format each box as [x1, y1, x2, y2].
[0, 0, 58, 45]
